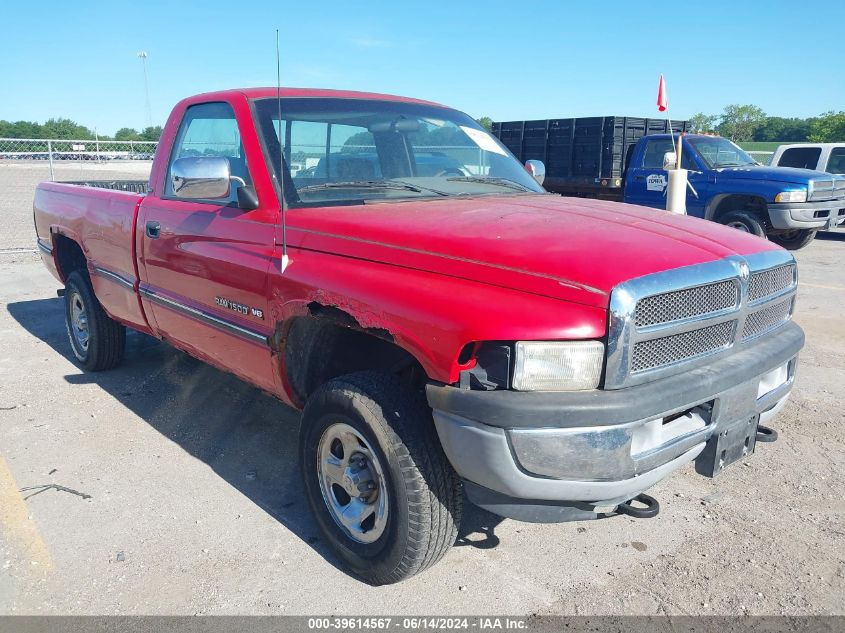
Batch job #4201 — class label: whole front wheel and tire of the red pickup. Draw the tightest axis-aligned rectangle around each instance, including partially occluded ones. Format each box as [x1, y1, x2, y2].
[300, 371, 463, 585]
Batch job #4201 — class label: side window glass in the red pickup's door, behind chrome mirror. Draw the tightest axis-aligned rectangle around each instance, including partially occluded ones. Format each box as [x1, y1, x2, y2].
[166, 103, 252, 203]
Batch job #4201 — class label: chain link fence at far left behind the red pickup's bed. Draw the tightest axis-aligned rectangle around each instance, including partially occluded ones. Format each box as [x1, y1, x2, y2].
[0, 138, 157, 254]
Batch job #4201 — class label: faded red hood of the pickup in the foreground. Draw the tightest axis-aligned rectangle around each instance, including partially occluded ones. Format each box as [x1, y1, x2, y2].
[288, 194, 779, 307]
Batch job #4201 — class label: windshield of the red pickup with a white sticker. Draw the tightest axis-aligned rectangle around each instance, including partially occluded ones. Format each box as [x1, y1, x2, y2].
[254, 98, 544, 206]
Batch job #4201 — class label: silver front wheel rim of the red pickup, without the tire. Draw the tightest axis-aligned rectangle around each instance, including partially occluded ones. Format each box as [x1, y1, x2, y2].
[317, 423, 388, 543]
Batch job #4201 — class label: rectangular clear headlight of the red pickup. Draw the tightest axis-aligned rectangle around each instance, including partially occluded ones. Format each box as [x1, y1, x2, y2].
[512, 341, 604, 391]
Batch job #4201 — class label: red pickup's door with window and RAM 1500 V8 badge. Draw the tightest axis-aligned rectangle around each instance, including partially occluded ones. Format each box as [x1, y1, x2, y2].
[138, 102, 278, 390]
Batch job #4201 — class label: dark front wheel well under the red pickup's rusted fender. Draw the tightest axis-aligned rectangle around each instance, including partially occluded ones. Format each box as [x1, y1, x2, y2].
[283, 314, 428, 403]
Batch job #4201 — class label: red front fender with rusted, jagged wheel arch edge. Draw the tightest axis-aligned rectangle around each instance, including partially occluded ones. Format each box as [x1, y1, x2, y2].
[269, 250, 607, 383]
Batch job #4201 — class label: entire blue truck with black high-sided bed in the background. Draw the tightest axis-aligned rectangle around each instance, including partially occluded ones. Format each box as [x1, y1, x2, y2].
[493, 117, 845, 250]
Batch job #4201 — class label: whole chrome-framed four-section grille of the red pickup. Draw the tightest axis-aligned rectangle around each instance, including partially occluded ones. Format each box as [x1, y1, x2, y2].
[603, 250, 797, 389]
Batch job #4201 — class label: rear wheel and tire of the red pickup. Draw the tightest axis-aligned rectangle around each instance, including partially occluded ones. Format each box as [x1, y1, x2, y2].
[65, 270, 126, 371]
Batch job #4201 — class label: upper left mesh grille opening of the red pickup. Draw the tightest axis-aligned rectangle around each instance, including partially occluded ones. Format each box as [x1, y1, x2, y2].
[634, 281, 739, 327]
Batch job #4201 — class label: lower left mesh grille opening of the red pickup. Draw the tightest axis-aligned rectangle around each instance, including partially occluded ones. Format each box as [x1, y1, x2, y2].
[631, 321, 736, 373]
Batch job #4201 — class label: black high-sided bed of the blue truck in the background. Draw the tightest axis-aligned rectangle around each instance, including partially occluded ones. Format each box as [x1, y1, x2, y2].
[493, 116, 689, 197]
